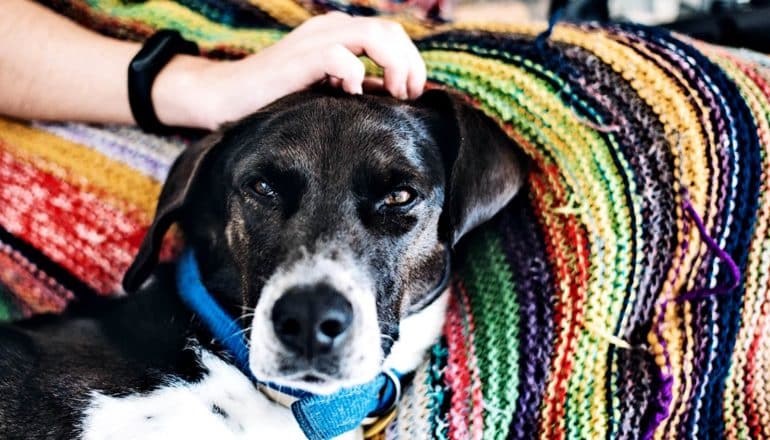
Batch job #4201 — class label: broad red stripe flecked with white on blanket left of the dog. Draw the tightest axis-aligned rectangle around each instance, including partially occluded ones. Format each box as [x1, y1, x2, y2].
[0, 150, 147, 294]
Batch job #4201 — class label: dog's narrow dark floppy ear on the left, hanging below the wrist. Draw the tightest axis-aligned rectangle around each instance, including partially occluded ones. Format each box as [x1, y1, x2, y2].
[123, 130, 222, 292]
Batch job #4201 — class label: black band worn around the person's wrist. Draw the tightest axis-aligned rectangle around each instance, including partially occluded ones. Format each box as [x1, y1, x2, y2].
[128, 30, 198, 134]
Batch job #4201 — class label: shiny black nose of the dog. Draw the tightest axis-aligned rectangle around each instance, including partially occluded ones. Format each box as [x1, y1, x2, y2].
[272, 284, 353, 359]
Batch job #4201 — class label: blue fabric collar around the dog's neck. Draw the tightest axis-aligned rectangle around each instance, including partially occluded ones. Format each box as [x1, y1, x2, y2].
[176, 249, 401, 440]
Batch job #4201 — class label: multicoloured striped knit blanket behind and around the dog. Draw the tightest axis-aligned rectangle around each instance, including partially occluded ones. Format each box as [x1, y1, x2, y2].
[0, 0, 770, 439]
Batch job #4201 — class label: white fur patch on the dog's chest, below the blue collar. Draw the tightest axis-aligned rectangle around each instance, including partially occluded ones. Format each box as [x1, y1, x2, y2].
[82, 351, 360, 440]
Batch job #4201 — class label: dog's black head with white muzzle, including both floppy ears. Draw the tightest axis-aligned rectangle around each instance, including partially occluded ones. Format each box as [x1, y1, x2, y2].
[124, 91, 521, 392]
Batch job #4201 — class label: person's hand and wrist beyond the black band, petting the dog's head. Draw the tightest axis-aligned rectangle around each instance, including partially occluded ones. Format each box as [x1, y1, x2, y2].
[153, 12, 426, 129]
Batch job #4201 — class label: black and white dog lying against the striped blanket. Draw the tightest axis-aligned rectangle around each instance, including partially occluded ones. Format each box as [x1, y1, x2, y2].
[0, 90, 522, 440]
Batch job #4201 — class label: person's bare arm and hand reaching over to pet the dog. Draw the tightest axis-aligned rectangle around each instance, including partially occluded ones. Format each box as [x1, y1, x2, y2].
[0, 0, 425, 129]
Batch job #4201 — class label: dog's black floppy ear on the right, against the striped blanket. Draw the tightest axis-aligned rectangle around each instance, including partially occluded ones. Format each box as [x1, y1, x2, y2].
[418, 90, 524, 246]
